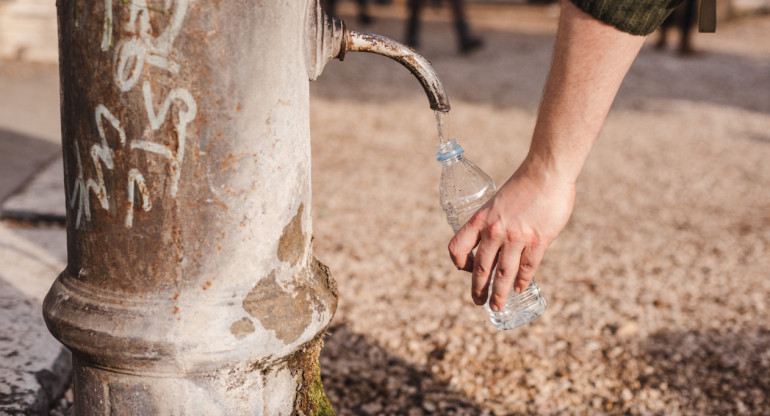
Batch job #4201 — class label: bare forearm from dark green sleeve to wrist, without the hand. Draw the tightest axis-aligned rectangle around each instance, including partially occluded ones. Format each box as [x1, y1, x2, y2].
[524, 0, 644, 183]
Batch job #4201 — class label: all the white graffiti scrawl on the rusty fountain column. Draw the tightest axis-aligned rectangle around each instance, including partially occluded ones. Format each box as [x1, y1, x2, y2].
[69, 0, 198, 228]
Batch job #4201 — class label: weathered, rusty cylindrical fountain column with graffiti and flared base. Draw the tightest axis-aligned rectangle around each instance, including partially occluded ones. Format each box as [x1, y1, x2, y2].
[44, 0, 340, 415]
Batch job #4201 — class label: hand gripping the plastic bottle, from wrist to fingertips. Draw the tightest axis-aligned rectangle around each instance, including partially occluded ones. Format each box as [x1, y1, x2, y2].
[449, 161, 575, 312]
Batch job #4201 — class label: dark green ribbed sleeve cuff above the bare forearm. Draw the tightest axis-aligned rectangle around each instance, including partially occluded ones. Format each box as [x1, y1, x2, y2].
[570, 0, 682, 35]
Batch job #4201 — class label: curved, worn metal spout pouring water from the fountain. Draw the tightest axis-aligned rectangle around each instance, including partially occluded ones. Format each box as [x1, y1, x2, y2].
[338, 30, 449, 112]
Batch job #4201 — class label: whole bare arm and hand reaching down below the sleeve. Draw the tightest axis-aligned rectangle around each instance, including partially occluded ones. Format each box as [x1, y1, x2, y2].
[449, 0, 644, 311]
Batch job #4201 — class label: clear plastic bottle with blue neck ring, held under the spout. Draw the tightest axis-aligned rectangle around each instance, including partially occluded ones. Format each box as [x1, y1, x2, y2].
[436, 140, 546, 330]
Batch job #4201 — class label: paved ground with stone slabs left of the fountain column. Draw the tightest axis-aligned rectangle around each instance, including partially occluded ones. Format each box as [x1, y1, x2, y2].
[0, 60, 72, 415]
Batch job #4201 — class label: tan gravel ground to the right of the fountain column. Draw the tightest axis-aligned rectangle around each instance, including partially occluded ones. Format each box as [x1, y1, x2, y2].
[311, 5, 770, 415]
